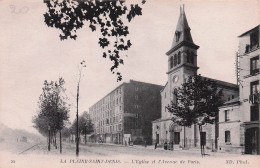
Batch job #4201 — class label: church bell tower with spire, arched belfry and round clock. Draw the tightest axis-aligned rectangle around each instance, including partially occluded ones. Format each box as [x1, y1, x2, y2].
[166, 5, 199, 96]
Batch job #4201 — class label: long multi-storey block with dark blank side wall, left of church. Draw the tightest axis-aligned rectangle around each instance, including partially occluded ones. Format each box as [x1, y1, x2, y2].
[89, 80, 162, 145]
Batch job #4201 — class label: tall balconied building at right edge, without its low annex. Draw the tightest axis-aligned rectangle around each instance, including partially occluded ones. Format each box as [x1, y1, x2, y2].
[239, 25, 260, 154]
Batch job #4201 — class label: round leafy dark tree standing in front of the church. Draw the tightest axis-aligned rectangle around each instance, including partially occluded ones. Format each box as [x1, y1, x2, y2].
[166, 75, 223, 154]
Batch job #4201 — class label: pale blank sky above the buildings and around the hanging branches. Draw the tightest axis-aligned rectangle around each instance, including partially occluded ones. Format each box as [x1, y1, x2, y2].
[0, 0, 260, 133]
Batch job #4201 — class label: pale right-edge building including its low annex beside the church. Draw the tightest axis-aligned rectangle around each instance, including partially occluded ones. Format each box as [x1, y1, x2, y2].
[219, 25, 260, 154]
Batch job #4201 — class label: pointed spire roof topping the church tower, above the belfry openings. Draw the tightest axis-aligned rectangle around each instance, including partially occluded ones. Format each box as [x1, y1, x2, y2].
[166, 5, 199, 55]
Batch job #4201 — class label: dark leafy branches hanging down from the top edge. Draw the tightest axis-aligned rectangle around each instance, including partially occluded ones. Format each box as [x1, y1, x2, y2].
[44, 0, 145, 81]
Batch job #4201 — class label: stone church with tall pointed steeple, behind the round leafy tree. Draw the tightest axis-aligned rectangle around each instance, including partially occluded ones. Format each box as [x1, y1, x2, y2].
[152, 6, 239, 150]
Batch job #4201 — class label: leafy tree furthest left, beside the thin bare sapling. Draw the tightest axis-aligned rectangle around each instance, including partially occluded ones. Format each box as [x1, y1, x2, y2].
[33, 78, 69, 152]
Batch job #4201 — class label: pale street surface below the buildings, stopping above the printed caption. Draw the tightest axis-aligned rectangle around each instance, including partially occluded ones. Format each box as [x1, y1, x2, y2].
[21, 143, 245, 158]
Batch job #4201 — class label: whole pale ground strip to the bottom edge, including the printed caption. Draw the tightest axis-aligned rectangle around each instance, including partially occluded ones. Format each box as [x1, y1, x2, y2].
[0, 141, 259, 168]
